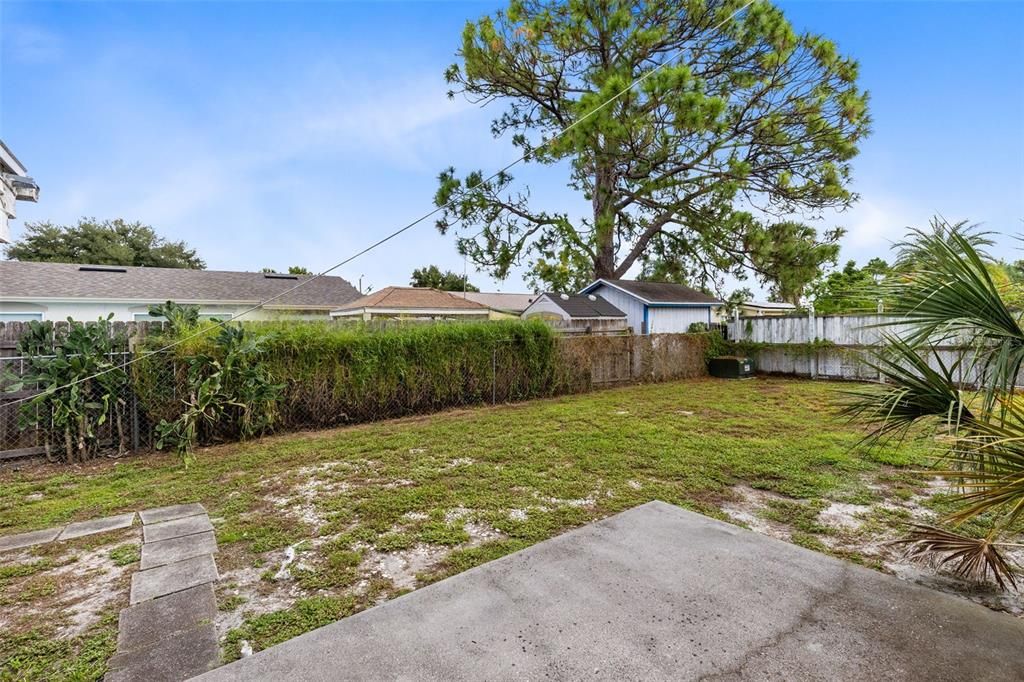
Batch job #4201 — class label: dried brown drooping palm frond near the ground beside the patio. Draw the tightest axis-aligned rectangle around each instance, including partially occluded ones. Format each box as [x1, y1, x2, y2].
[890, 524, 1017, 590]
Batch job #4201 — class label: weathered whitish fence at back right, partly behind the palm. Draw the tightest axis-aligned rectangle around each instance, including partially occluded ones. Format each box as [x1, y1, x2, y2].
[729, 314, 975, 384]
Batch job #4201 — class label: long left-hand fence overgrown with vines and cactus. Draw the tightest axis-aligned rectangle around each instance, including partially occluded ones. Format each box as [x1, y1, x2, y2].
[0, 323, 703, 463]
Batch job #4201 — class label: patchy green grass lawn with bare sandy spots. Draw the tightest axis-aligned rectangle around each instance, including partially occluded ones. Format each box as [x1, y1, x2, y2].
[0, 379, 991, 679]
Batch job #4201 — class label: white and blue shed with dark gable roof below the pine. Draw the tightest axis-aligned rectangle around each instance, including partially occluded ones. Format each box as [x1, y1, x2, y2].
[580, 279, 722, 334]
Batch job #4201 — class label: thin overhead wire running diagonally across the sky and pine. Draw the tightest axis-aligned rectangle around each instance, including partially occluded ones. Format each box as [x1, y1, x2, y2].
[7, 0, 758, 406]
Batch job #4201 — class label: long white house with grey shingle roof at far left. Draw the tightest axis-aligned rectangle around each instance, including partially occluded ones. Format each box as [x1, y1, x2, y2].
[0, 260, 359, 322]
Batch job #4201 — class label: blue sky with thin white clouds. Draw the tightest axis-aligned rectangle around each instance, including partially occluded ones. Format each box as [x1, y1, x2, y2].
[0, 0, 1024, 291]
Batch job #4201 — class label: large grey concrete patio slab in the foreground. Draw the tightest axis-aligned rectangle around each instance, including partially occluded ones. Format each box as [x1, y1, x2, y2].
[200, 502, 1024, 682]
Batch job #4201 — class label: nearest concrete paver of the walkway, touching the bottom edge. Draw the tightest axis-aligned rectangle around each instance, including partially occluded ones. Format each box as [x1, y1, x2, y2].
[103, 624, 220, 682]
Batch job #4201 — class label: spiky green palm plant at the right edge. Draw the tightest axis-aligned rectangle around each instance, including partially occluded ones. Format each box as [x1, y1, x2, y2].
[843, 219, 1024, 587]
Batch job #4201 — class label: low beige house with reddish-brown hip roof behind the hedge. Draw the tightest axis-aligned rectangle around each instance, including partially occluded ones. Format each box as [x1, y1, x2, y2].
[331, 287, 490, 322]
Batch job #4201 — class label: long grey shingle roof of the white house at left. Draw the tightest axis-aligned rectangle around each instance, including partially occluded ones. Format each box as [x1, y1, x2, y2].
[0, 260, 359, 309]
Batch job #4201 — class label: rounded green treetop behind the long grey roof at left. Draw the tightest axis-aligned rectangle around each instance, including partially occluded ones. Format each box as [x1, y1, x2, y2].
[7, 218, 206, 269]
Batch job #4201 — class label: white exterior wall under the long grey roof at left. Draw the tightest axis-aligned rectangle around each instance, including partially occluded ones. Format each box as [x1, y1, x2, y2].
[0, 300, 330, 322]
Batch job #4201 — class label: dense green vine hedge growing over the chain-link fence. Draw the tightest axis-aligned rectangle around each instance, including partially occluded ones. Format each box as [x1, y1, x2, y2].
[134, 321, 557, 436]
